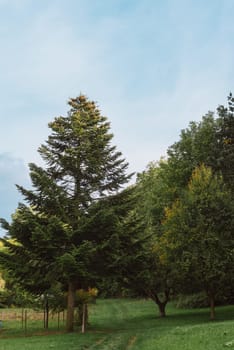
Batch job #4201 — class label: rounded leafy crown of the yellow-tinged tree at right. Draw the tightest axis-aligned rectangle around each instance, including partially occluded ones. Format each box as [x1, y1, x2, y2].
[162, 165, 234, 318]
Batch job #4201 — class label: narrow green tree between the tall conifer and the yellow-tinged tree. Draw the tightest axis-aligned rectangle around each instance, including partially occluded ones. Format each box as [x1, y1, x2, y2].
[122, 160, 181, 316]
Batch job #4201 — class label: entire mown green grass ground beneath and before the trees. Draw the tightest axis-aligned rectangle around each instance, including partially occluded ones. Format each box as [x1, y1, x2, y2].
[0, 299, 234, 350]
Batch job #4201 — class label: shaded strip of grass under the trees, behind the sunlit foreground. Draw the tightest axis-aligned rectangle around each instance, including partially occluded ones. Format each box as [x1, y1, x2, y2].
[0, 300, 234, 338]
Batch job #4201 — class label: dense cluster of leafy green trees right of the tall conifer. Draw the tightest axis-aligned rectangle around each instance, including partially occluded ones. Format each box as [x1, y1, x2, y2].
[128, 94, 234, 318]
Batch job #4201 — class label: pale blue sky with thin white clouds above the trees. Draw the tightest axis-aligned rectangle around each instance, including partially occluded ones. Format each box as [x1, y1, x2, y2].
[0, 0, 234, 227]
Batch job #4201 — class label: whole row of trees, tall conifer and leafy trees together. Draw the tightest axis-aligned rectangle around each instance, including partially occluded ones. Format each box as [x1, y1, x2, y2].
[0, 94, 234, 331]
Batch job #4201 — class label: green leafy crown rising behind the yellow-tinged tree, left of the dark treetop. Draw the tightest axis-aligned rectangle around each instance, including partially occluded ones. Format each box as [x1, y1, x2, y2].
[164, 112, 219, 199]
